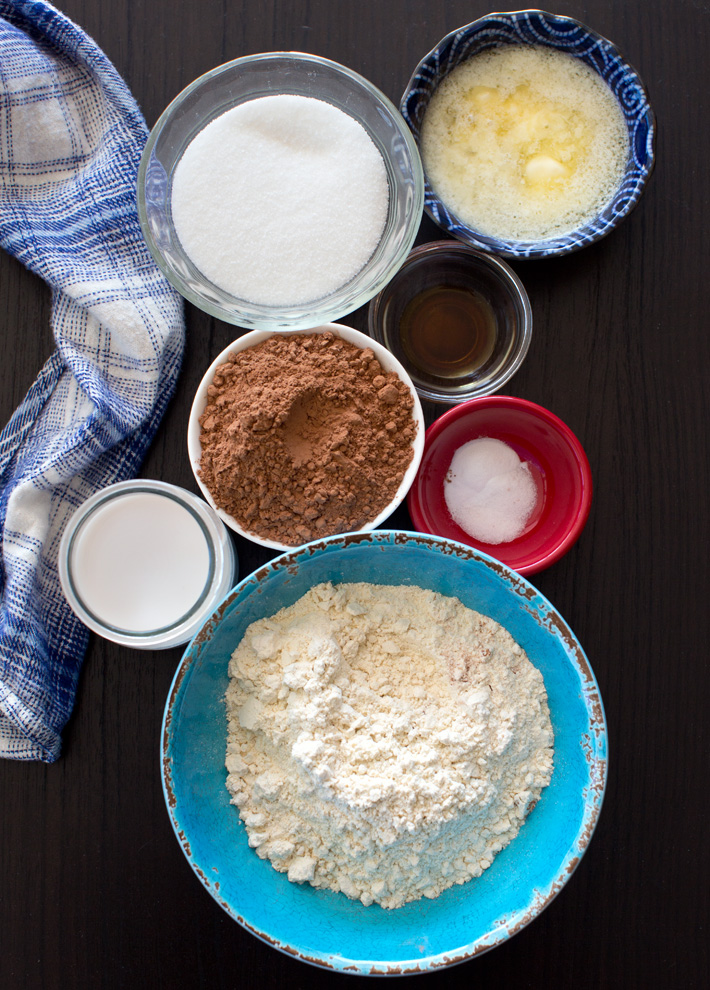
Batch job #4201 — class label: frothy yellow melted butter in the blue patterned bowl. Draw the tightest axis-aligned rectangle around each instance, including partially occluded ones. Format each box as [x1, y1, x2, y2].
[421, 45, 628, 240]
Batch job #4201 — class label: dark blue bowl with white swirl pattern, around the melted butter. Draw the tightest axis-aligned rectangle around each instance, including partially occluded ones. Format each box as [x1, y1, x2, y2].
[400, 10, 655, 258]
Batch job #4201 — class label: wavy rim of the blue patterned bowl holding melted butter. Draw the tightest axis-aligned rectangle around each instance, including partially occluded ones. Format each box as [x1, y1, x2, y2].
[399, 7, 658, 261]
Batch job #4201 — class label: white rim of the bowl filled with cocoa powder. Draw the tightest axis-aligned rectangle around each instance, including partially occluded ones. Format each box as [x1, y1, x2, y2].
[187, 323, 426, 553]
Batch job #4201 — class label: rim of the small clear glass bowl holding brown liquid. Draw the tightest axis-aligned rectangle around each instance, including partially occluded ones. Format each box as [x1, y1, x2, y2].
[367, 239, 533, 405]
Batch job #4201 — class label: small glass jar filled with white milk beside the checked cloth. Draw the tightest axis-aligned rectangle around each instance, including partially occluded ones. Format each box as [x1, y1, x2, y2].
[58, 479, 237, 650]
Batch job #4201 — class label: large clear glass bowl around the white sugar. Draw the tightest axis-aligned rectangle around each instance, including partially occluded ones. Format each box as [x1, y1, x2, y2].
[138, 52, 424, 331]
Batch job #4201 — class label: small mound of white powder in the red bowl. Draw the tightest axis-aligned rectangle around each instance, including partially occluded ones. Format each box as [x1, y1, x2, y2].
[444, 437, 537, 546]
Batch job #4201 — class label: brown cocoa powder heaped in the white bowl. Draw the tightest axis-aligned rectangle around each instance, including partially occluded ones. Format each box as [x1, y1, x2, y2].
[199, 331, 417, 546]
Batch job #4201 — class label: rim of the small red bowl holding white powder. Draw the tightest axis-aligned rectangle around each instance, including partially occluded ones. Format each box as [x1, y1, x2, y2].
[407, 395, 594, 576]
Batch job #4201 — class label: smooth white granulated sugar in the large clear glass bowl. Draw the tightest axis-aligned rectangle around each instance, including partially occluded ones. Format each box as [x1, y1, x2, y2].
[172, 95, 389, 306]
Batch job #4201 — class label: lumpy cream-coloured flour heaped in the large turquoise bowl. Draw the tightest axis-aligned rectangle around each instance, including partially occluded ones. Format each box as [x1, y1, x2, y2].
[226, 583, 553, 908]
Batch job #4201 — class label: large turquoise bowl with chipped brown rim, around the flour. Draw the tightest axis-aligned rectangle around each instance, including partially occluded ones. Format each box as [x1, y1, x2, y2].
[161, 530, 606, 975]
